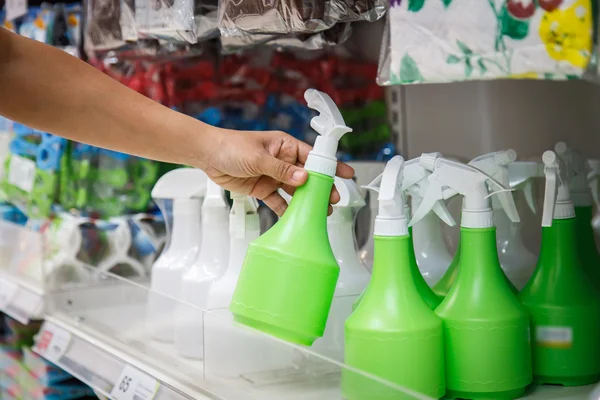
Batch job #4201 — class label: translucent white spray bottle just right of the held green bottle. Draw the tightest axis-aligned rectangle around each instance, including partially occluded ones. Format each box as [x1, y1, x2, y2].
[314, 177, 371, 361]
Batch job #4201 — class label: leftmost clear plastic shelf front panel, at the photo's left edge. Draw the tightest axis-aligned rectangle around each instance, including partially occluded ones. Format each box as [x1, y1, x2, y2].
[0, 221, 45, 324]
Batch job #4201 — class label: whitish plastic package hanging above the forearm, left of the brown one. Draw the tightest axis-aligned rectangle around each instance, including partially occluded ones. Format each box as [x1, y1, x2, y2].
[135, 0, 197, 43]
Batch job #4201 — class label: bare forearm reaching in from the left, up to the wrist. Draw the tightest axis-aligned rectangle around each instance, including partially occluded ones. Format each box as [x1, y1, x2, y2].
[0, 28, 219, 167]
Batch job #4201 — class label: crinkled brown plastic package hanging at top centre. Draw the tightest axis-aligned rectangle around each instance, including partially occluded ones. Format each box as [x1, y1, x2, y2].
[219, 0, 387, 36]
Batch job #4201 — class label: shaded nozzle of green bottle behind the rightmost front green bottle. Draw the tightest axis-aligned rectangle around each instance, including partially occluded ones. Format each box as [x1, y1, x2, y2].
[554, 142, 593, 207]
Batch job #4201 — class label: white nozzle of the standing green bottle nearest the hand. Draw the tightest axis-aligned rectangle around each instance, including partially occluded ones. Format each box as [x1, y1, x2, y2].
[365, 156, 408, 236]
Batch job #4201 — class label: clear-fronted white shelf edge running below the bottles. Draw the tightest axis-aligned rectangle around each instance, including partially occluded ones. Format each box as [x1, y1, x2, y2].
[37, 266, 429, 400]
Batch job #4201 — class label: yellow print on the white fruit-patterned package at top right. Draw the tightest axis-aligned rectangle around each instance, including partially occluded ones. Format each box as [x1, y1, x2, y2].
[539, 0, 592, 68]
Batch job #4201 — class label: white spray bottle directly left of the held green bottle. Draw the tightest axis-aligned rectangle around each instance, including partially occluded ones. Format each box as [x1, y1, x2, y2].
[206, 193, 260, 310]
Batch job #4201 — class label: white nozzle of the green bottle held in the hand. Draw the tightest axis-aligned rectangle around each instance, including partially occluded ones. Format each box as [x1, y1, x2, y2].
[304, 89, 352, 177]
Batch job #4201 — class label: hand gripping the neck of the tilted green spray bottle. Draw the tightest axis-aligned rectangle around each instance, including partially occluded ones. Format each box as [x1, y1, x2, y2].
[203, 130, 354, 216]
